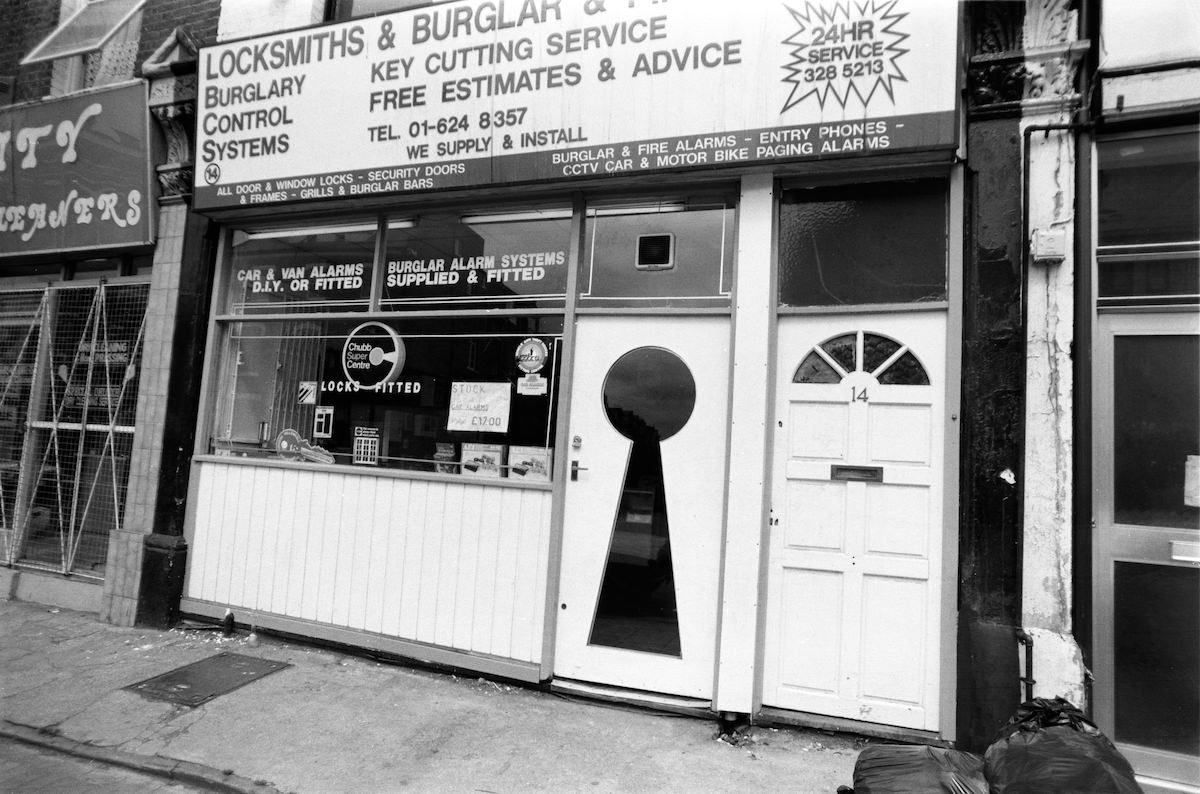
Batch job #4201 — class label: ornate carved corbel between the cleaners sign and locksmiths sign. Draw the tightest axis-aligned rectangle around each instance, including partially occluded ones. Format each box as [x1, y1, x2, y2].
[142, 28, 199, 204]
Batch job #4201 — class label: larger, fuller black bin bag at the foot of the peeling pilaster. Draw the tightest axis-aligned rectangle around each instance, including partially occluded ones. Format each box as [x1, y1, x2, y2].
[984, 698, 1141, 794]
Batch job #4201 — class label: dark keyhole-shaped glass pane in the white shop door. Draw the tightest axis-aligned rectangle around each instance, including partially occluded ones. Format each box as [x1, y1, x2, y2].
[589, 347, 696, 656]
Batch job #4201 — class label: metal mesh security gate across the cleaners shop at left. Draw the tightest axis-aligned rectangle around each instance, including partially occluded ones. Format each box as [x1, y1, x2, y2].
[0, 283, 149, 577]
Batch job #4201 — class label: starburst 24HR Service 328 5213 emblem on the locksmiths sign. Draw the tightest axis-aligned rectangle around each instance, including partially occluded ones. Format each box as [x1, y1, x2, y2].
[780, 0, 908, 113]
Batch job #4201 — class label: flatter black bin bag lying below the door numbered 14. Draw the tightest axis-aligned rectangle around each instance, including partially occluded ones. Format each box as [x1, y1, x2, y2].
[853, 745, 988, 794]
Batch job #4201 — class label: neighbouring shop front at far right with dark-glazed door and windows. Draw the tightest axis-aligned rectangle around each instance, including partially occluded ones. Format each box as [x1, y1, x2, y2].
[1080, 4, 1200, 792]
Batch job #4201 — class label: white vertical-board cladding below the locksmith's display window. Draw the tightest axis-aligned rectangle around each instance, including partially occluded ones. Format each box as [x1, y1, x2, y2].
[184, 462, 551, 662]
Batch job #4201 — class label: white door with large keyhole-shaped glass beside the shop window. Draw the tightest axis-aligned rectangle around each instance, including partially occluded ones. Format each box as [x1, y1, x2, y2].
[554, 317, 728, 698]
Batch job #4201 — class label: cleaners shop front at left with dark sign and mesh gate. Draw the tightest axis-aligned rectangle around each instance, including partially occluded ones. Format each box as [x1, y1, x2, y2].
[0, 82, 155, 604]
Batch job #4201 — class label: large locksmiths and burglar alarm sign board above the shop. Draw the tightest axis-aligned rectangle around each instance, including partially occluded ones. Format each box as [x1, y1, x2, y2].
[196, 0, 960, 209]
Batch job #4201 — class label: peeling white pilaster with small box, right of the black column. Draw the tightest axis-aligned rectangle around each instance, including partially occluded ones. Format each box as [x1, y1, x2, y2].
[1021, 0, 1087, 708]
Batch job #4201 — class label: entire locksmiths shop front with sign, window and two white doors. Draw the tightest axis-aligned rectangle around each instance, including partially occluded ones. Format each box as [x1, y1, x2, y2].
[182, 2, 962, 736]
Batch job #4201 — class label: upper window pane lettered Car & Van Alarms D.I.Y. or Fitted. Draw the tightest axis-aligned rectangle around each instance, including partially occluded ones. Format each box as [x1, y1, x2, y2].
[228, 223, 376, 314]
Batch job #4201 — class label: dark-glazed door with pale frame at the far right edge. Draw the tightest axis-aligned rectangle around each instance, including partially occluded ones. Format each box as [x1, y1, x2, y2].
[1093, 312, 1200, 787]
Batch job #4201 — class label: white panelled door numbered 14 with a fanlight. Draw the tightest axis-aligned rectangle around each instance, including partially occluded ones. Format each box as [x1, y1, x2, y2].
[763, 312, 946, 730]
